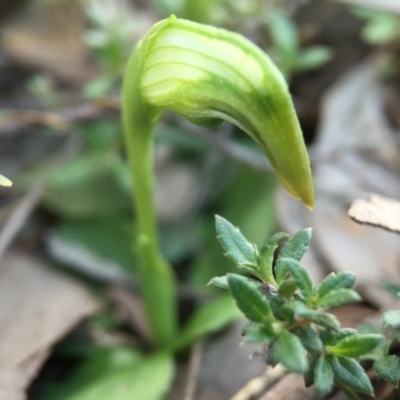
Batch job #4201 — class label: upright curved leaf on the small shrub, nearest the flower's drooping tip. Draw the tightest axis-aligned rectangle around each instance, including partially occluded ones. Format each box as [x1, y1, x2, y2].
[275, 228, 312, 284]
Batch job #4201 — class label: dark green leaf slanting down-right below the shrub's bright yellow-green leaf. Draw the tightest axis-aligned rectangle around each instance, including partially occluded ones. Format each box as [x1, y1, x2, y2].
[329, 356, 374, 395]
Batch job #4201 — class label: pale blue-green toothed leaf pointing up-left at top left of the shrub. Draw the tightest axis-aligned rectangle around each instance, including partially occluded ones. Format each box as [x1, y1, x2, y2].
[215, 215, 257, 267]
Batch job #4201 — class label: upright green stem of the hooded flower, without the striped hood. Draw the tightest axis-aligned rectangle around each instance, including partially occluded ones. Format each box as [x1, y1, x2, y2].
[122, 42, 177, 347]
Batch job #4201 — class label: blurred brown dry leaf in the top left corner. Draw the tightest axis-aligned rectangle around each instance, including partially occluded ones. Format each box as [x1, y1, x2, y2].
[0, 1, 95, 83]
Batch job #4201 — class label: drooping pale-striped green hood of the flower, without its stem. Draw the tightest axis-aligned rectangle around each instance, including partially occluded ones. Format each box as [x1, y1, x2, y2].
[124, 16, 314, 208]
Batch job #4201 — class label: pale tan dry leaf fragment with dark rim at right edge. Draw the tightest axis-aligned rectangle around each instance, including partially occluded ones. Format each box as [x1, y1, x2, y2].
[349, 194, 400, 233]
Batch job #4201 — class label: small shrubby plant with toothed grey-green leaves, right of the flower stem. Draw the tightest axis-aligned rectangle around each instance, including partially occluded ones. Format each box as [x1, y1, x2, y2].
[209, 216, 400, 399]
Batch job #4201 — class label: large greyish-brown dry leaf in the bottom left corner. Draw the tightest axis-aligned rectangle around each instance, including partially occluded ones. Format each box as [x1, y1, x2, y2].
[0, 254, 96, 400]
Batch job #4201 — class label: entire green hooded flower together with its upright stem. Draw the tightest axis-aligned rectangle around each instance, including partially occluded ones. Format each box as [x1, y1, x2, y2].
[122, 16, 314, 346]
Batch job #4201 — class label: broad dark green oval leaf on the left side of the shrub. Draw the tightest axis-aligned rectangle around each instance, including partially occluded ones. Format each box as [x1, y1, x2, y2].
[228, 274, 271, 323]
